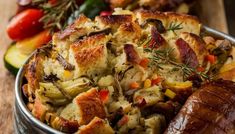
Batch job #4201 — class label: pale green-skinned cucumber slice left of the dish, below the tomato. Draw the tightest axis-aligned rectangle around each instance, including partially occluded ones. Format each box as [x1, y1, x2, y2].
[4, 44, 28, 75]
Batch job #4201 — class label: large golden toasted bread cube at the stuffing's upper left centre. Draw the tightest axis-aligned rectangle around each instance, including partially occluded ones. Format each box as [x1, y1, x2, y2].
[69, 34, 110, 77]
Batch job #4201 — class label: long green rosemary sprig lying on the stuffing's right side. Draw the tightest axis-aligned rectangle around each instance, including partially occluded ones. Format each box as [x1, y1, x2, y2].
[144, 47, 212, 80]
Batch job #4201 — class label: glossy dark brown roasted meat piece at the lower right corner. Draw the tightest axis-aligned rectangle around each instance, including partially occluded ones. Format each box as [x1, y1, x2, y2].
[165, 79, 235, 134]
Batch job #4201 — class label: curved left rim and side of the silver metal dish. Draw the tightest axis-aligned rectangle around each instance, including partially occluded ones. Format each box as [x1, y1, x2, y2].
[14, 61, 61, 134]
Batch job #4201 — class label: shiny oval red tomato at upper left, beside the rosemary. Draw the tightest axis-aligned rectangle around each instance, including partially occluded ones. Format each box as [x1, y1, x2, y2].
[7, 9, 43, 41]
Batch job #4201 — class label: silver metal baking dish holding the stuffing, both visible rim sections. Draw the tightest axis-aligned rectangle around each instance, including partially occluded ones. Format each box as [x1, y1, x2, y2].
[14, 26, 235, 134]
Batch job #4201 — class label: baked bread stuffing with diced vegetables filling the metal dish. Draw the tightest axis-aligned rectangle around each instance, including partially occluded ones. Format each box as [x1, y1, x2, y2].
[23, 8, 235, 134]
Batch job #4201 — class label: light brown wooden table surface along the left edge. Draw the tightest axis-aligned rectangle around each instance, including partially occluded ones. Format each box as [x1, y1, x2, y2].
[0, 0, 16, 134]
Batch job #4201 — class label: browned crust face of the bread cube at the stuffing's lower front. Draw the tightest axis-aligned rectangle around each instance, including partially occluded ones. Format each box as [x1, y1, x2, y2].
[74, 88, 106, 125]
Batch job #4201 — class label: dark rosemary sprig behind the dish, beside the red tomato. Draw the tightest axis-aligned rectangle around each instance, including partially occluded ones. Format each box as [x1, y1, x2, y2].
[32, 0, 79, 31]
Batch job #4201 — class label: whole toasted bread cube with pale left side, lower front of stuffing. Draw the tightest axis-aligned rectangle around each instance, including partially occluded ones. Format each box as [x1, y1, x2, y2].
[61, 88, 106, 125]
